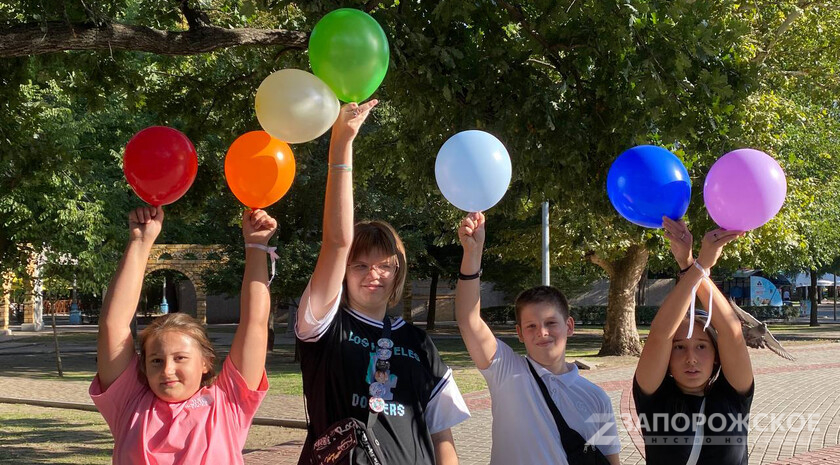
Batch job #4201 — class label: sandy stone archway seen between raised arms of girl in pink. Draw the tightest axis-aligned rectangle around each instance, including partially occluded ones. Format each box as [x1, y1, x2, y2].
[143, 244, 224, 323]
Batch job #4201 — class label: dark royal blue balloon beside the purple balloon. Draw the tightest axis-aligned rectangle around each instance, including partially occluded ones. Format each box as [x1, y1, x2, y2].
[607, 145, 691, 228]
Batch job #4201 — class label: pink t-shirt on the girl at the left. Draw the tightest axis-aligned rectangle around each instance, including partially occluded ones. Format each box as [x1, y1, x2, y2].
[89, 354, 268, 465]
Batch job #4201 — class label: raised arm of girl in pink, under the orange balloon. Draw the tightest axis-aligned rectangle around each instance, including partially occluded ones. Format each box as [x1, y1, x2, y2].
[230, 210, 277, 390]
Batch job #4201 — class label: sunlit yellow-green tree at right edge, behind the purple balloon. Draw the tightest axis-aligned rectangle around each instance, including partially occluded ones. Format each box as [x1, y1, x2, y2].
[720, 1, 840, 326]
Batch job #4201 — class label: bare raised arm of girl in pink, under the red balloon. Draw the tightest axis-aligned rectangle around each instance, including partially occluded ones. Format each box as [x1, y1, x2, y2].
[96, 207, 163, 391]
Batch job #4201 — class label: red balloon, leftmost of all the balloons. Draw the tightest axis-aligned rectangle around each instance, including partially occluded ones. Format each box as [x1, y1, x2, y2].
[123, 126, 198, 207]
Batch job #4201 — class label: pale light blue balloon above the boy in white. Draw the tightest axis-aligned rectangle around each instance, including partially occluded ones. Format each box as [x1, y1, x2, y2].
[435, 130, 511, 212]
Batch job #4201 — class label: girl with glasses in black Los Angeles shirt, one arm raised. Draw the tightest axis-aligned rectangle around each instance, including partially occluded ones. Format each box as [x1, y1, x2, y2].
[295, 100, 469, 465]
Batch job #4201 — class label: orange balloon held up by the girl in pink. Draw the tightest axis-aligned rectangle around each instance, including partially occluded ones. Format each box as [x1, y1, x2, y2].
[225, 131, 295, 208]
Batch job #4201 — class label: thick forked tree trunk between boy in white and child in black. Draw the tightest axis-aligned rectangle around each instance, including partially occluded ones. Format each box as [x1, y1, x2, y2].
[589, 244, 649, 356]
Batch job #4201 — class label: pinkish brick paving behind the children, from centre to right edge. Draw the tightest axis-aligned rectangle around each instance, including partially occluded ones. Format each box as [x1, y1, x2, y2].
[246, 343, 840, 465]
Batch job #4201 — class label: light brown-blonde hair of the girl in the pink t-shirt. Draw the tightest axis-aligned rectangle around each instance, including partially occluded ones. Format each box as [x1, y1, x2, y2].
[137, 313, 216, 386]
